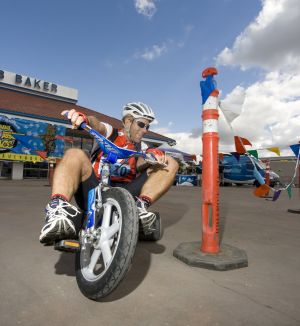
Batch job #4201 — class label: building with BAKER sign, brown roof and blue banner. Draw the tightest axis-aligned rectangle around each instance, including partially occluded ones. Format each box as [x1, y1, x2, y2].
[0, 70, 176, 179]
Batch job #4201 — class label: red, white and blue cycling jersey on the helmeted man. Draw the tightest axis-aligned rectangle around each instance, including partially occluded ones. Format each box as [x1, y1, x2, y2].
[91, 128, 141, 182]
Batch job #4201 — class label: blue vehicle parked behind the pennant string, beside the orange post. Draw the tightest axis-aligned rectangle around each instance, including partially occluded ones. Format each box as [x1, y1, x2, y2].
[220, 154, 280, 187]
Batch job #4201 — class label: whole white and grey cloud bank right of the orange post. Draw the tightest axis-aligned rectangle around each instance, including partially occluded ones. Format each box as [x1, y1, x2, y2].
[217, 0, 300, 155]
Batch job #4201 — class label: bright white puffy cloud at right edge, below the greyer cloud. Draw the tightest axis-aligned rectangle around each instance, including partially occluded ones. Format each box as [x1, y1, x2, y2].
[227, 74, 300, 148]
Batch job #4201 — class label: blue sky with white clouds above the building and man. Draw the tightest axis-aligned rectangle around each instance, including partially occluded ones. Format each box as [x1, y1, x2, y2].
[0, 0, 300, 156]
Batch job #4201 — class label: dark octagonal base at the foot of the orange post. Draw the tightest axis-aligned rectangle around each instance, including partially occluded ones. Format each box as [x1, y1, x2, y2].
[173, 241, 248, 271]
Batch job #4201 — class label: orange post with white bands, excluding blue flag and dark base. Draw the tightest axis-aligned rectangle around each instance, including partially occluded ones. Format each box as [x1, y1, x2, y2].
[201, 68, 220, 254]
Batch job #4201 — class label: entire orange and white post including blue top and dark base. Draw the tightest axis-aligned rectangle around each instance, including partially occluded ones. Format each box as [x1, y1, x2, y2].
[173, 68, 248, 271]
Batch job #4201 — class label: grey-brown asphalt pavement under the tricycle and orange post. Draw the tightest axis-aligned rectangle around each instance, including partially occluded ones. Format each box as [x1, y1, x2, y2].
[0, 180, 300, 326]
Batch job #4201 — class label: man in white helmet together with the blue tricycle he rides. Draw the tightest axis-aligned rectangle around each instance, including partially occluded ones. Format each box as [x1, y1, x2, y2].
[40, 102, 178, 299]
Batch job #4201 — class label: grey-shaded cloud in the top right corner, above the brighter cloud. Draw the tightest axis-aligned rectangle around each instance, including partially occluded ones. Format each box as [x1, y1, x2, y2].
[217, 0, 300, 71]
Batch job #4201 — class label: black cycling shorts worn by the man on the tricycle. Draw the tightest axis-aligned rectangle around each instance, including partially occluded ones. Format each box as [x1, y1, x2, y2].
[74, 171, 148, 210]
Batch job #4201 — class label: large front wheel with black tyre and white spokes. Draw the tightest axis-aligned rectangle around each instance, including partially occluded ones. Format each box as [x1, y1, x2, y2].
[75, 188, 139, 300]
